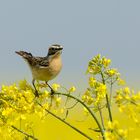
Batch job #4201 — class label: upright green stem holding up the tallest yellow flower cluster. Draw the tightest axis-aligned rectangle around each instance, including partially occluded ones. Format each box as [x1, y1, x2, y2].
[101, 72, 113, 122]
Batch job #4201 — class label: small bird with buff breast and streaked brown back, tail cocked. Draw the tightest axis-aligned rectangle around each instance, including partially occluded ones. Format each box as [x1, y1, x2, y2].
[15, 44, 63, 97]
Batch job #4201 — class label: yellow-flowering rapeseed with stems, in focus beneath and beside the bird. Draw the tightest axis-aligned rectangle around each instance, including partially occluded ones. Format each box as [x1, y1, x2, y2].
[0, 54, 140, 140]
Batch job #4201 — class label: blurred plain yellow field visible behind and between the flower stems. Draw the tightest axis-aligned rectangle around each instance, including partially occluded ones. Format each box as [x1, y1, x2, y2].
[23, 107, 140, 140]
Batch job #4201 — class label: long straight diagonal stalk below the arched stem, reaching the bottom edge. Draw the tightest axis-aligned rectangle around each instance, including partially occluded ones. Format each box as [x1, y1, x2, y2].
[37, 102, 93, 140]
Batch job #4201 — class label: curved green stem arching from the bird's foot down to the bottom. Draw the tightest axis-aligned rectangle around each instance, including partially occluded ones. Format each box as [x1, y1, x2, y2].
[54, 92, 105, 140]
